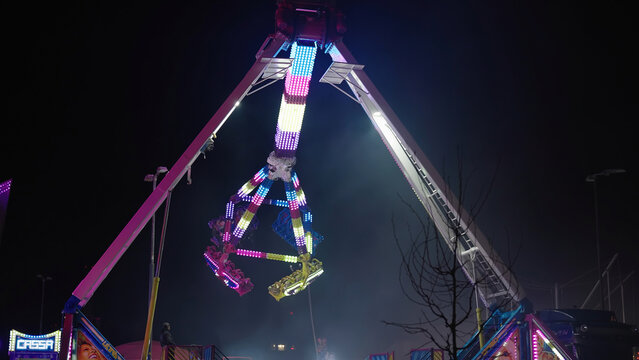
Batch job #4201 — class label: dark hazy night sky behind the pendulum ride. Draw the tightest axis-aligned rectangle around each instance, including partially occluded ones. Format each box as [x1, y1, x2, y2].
[0, 0, 639, 359]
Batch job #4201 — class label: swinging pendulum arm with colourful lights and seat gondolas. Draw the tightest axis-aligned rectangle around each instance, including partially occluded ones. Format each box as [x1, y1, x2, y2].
[204, 40, 324, 301]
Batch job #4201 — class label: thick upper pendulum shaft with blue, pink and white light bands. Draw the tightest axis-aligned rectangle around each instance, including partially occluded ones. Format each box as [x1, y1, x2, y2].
[275, 42, 317, 157]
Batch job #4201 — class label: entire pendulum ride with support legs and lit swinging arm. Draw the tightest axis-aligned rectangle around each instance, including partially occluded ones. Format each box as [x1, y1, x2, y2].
[51, 1, 616, 360]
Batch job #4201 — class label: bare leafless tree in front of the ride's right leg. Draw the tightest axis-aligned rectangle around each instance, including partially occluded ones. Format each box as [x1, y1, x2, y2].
[383, 160, 516, 360]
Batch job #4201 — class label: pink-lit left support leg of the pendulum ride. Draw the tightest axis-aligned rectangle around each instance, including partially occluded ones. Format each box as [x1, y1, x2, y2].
[69, 33, 287, 307]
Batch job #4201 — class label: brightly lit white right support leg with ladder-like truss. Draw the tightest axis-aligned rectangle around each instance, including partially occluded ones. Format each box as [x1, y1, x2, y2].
[327, 41, 525, 306]
